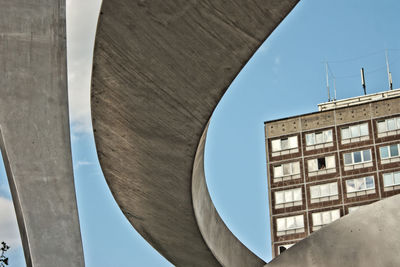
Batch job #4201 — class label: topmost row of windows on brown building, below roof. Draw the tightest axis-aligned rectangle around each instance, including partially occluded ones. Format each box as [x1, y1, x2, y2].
[271, 117, 400, 152]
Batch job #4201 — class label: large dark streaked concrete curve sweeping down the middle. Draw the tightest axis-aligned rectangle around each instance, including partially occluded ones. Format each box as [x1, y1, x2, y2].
[91, 0, 298, 266]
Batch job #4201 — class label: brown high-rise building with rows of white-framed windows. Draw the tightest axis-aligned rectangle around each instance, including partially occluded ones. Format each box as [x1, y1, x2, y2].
[265, 89, 400, 257]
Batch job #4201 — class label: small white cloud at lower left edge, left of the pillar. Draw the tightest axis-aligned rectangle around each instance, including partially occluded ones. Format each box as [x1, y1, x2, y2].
[0, 197, 21, 249]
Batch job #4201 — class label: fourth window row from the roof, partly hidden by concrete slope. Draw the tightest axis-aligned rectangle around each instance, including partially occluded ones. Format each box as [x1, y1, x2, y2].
[276, 206, 361, 236]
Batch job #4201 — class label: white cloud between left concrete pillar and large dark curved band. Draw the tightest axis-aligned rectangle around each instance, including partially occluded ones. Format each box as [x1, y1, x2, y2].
[66, 0, 101, 133]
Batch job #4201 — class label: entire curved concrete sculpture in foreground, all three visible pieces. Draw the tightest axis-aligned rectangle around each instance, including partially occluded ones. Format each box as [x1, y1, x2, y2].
[0, 0, 400, 266]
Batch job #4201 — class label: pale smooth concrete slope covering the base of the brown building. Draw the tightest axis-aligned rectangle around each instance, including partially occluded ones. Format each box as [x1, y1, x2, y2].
[265, 195, 400, 267]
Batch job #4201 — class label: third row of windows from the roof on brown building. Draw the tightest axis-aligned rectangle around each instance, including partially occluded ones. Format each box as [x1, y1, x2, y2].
[274, 176, 384, 209]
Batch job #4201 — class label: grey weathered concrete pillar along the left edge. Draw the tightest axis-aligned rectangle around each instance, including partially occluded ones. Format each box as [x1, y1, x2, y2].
[0, 0, 84, 267]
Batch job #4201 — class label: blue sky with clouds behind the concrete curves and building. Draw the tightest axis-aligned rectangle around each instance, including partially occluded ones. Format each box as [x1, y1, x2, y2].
[0, 0, 400, 267]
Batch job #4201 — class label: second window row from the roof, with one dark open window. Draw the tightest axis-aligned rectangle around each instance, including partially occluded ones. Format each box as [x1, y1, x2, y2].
[273, 144, 400, 182]
